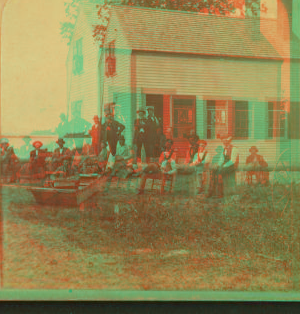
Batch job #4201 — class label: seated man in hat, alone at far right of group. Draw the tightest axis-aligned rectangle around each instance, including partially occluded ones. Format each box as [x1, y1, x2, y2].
[246, 146, 269, 184]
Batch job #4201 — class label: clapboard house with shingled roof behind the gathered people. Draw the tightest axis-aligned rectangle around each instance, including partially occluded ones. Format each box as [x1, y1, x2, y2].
[67, 1, 300, 165]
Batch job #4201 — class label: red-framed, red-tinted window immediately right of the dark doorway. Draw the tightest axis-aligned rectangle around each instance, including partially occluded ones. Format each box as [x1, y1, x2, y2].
[173, 97, 195, 139]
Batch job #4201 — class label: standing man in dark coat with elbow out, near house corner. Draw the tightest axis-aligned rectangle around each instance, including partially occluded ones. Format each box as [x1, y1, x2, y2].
[102, 112, 125, 157]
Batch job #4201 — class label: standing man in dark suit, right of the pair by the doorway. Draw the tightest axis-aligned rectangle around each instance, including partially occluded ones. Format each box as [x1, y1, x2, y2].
[145, 106, 159, 163]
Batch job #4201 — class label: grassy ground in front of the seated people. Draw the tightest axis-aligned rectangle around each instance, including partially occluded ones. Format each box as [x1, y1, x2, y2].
[2, 180, 300, 291]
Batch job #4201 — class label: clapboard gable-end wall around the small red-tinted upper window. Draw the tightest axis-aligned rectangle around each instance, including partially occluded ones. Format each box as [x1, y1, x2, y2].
[99, 12, 135, 145]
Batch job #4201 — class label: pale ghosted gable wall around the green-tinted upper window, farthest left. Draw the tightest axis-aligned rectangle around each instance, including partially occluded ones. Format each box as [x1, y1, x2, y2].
[67, 7, 100, 123]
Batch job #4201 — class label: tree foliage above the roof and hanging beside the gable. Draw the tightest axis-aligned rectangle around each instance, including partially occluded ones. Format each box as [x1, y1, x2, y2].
[61, 0, 267, 47]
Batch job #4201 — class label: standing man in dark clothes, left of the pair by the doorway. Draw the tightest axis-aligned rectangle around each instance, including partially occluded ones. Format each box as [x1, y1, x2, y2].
[133, 109, 147, 163]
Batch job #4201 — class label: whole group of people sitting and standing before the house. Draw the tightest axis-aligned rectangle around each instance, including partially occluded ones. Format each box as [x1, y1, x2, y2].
[0, 107, 269, 198]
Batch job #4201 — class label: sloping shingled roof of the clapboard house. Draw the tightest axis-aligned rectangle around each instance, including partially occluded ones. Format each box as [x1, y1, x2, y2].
[112, 5, 281, 59]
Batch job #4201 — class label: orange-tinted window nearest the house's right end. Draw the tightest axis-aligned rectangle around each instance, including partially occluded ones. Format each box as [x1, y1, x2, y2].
[268, 102, 286, 138]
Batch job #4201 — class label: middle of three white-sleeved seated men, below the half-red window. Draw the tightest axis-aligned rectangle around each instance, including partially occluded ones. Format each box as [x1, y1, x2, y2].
[190, 140, 210, 193]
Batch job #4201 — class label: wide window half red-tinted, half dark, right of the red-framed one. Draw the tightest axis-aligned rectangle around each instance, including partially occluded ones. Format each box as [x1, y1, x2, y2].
[207, 100, 248, 139]
